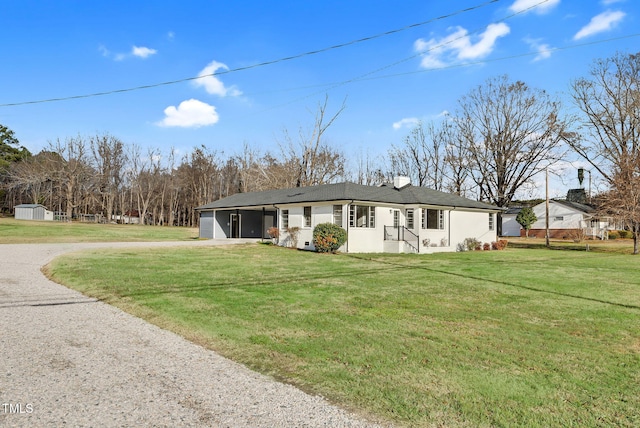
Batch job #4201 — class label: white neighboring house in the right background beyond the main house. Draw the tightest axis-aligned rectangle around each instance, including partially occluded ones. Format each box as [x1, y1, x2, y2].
[522, 199, 615, 239]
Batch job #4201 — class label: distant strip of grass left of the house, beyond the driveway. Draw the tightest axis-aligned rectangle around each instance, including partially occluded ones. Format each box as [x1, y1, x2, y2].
[0, 217, 198, 244]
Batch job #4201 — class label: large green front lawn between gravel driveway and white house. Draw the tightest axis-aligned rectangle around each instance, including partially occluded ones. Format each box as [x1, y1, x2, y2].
[48, 245, 640, 427]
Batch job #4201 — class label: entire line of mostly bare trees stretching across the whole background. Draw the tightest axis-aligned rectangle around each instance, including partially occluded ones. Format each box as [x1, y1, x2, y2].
[0, 53, 640, 252]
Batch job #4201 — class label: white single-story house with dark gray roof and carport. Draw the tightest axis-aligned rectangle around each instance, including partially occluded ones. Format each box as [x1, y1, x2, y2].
[196, 177, 501, 253]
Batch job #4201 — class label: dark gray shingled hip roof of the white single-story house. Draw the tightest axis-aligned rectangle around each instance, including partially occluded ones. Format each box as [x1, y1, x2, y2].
[196, 182, 499, 210]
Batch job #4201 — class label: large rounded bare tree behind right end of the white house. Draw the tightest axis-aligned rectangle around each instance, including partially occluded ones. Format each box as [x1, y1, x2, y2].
[456, 76, 568, 233]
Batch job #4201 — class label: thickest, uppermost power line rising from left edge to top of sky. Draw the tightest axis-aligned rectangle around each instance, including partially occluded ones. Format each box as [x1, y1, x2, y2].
[0, 0, 500, 107]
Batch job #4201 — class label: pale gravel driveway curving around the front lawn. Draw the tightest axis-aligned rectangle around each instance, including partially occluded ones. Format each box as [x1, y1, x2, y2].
[0, 241, 382, 427]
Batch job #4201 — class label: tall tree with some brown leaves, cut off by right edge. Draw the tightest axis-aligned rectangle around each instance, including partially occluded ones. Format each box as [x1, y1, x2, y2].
[567, 53, 640, 254]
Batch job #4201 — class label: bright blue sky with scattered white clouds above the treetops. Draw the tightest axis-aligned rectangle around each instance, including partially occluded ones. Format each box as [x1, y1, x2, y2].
[0, 0, 640, 197]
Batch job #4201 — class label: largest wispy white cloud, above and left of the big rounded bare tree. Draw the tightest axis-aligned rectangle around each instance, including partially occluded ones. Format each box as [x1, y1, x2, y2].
[414, 23, 511, 68]
